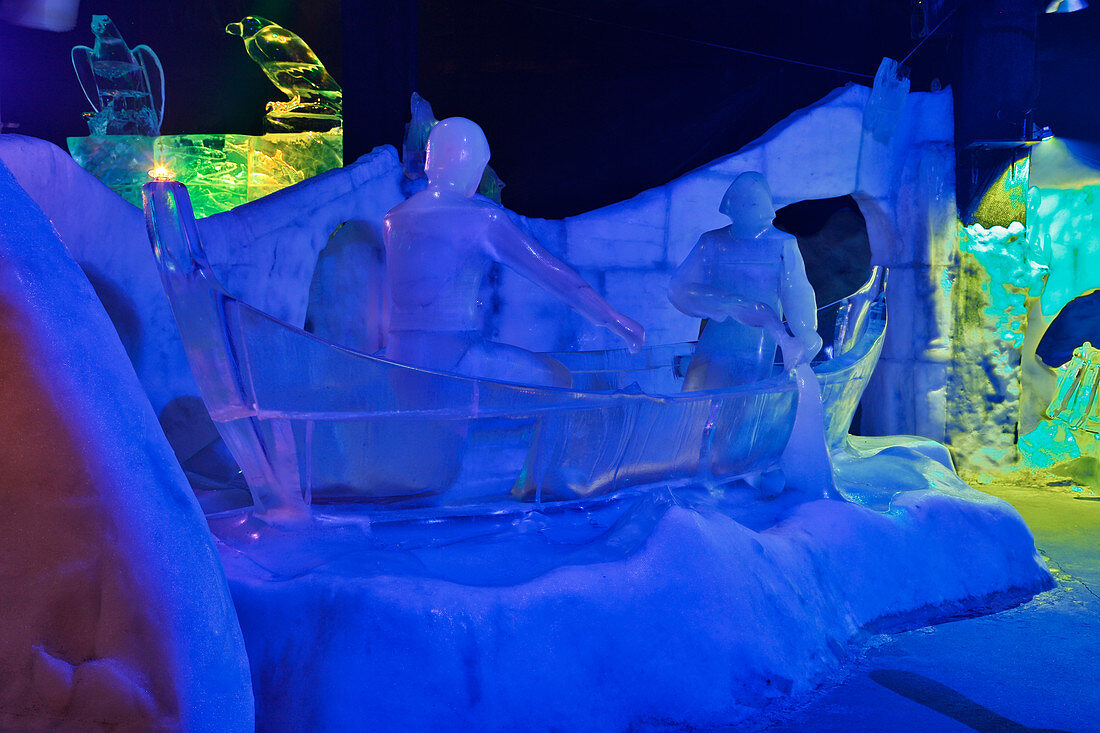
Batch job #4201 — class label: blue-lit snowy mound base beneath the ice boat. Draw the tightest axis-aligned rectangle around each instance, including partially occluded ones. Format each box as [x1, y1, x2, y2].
[211, 439, 1051, 731]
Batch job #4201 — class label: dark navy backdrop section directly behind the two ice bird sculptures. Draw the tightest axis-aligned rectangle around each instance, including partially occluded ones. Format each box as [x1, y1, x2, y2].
[0, 0, 342, 146]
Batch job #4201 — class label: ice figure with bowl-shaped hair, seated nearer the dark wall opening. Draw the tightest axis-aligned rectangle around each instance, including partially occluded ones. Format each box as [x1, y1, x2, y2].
[669, 173, 822, 392]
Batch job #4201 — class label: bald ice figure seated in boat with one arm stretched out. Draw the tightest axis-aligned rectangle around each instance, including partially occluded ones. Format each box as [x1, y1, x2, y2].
[383, 117, 645, 386]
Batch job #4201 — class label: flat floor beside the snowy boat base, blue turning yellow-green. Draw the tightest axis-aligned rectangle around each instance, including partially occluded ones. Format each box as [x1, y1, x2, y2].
[761, 477, 1100, 733]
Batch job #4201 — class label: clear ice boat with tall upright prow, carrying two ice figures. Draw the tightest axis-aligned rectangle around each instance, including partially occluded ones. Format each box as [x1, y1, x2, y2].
[145, 182, 886, 514]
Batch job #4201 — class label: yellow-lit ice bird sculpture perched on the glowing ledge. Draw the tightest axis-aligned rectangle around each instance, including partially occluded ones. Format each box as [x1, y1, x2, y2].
[226, 15, 343, 132]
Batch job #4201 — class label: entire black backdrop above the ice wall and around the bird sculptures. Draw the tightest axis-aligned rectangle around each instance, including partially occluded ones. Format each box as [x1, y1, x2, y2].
[0, 0, 1100, 217]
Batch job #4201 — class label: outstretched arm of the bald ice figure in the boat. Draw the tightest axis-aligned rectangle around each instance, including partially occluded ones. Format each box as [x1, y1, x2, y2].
[488, 211, 646, 353]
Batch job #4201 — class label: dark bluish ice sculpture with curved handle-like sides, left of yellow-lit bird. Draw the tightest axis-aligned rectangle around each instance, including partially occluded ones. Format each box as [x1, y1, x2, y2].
[70, 15, 164, 136]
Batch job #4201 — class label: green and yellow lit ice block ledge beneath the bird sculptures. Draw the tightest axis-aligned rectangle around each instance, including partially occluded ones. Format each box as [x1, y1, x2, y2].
[68, 131, 343, 217]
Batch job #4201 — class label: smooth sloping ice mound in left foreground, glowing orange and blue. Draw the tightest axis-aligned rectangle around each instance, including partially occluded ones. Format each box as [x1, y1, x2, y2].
[0, 157, 253, 731]
